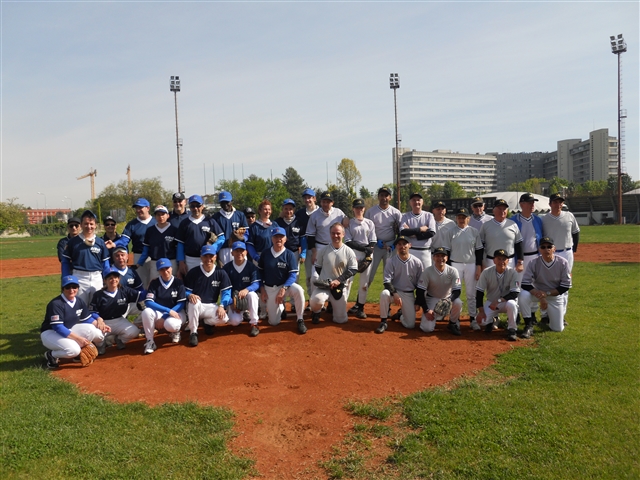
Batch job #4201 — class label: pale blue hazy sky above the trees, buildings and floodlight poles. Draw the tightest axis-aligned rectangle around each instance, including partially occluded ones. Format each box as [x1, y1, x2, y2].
[1, 1, 640, 208]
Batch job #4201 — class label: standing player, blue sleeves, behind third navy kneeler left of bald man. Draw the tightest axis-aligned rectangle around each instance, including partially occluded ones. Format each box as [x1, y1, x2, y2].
[176, 195, 225, 278]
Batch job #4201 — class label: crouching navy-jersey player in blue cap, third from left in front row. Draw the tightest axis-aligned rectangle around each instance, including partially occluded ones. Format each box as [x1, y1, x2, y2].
[140, 258, 186, 355]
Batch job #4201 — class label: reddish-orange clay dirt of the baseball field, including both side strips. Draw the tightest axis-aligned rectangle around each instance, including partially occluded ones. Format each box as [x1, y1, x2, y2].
[0, 244, 640, 479]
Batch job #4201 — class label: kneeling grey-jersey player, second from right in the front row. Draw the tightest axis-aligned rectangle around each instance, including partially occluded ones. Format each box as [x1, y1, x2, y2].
[476, 248, 520, 342]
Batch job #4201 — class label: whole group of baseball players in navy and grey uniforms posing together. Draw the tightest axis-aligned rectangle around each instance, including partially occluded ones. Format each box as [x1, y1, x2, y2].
[41, 187, 579, 368]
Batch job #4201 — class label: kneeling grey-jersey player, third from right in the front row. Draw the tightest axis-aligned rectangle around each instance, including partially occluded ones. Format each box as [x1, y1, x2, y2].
[420, 247, 462, 335]
